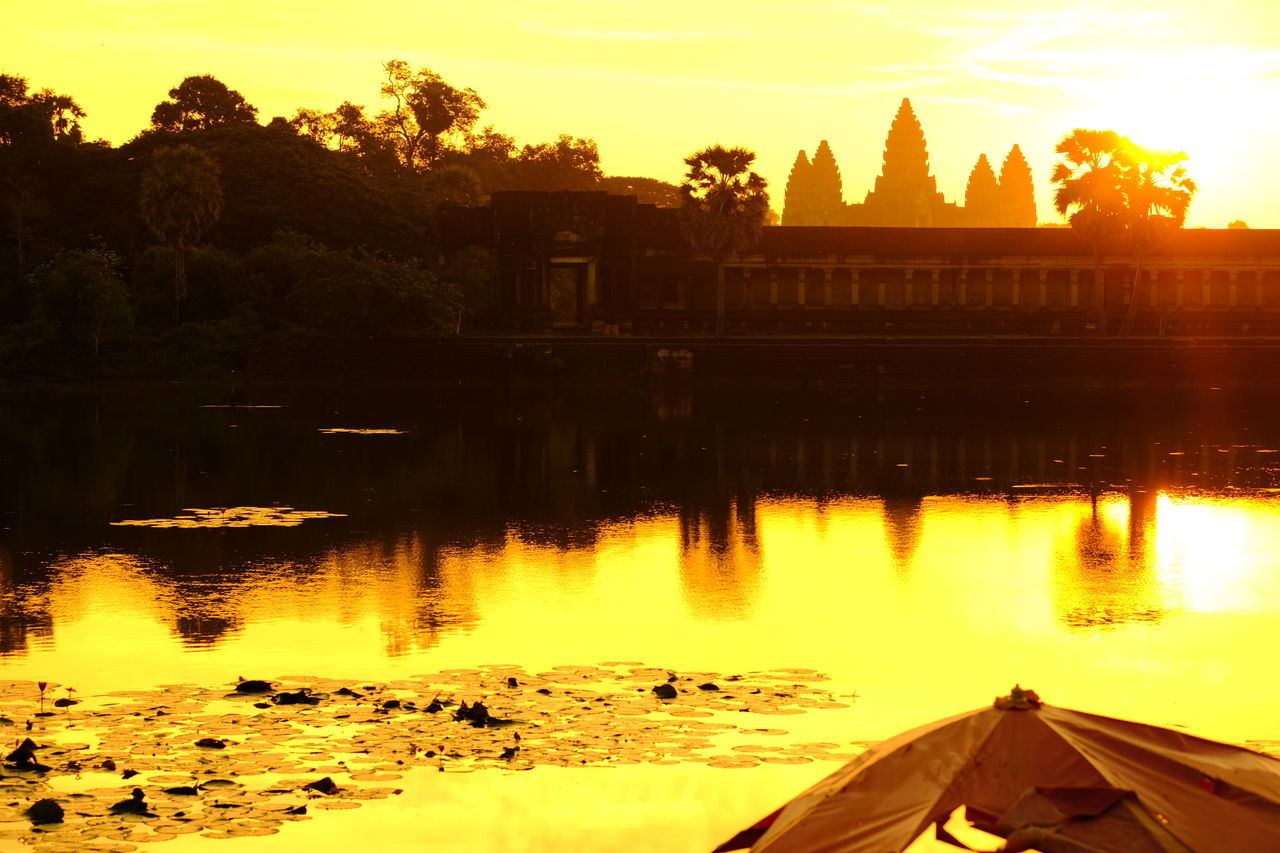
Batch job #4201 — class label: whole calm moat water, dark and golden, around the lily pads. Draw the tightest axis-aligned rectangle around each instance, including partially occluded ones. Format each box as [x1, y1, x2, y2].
[0, 388, 1280, 852]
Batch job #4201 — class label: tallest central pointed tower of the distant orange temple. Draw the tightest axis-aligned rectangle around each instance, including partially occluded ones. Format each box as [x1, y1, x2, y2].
[863, 97, 948, 227]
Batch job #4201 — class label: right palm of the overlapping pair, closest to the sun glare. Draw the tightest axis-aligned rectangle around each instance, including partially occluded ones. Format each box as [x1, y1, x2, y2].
[1120, 140, 1196, 334]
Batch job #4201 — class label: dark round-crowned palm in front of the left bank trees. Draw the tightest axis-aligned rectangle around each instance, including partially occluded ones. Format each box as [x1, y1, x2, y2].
[138, 145, 223, 321]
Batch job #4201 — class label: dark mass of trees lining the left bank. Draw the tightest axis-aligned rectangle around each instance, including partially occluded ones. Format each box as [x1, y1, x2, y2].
[0, 61, 678, 374]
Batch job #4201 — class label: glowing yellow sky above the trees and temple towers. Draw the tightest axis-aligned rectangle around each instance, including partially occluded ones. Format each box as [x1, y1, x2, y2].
[0, 0, 1280, 227]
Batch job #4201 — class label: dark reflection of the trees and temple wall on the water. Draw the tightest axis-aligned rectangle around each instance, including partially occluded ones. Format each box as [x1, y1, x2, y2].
[0, 386, 1275, 656]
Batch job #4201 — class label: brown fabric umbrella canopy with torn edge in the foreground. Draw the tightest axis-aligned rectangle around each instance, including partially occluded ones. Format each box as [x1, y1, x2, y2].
[717, 688, 1280, 853]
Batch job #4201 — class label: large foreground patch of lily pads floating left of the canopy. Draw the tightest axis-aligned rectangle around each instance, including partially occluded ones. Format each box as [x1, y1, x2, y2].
[0, 662, 858, 853]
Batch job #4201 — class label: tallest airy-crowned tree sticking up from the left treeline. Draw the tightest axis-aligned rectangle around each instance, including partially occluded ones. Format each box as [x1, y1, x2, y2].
[374, 59, 485, 172]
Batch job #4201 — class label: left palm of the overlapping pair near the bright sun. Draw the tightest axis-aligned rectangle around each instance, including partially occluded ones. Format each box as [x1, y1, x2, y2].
[1050, 128, 1126, 334]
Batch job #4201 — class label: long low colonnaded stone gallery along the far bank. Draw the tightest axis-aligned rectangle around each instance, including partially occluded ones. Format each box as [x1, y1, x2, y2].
[444, 189, 1280, 336]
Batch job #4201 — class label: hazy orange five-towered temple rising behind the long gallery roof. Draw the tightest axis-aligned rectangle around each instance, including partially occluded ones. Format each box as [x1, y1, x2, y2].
[782, 99, 1036, 228]
